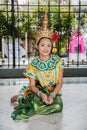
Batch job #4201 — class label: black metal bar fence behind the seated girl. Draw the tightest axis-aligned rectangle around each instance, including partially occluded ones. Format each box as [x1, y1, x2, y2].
[0, 0, 87, 68]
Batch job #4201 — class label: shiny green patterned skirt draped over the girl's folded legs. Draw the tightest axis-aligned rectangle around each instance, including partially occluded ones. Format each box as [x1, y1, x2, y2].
[11, 85, 63, 120]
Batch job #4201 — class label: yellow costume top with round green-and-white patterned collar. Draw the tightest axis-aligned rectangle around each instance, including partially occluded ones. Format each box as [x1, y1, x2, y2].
[23, 55, 64, 88]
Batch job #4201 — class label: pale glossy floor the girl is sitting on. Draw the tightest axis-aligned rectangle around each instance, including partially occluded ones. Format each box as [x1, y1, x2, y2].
[0, 77, 87, 130]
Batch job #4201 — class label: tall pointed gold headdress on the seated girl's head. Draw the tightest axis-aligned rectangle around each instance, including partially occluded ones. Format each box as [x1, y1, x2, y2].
[36, 2, 59, 43]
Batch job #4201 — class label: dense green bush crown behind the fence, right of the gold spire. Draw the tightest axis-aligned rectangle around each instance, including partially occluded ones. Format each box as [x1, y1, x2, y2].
[51, 7, 75, 41]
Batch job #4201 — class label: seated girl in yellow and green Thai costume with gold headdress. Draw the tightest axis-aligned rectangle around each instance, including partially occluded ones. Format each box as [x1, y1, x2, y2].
[11, 6, 64, 120]
